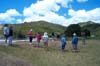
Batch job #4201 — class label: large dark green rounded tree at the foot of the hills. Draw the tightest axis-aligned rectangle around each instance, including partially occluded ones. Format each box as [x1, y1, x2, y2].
[65, 24, 81, 37]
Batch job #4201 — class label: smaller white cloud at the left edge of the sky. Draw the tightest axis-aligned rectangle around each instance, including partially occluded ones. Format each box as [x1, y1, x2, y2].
[0, 9, 21, 22]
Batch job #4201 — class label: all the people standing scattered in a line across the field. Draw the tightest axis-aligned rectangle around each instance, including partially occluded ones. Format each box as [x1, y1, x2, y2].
[3, 24, 85, 51]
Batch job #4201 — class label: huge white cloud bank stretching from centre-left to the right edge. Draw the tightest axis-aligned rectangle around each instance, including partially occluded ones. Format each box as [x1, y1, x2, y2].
[23, 0, 100, 26]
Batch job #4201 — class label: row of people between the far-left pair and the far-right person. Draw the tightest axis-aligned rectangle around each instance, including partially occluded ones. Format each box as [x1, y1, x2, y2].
[28, 29, 78, 51]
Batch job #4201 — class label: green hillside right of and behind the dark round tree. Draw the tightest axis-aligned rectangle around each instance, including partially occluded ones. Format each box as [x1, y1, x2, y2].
[79, 21, 100, 38]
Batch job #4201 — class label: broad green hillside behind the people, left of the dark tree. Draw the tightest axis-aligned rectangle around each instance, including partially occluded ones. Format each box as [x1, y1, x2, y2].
[13, 21, 65, 38]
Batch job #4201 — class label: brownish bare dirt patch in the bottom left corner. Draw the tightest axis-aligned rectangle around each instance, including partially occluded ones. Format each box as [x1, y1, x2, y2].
[0, 52, 32, 66]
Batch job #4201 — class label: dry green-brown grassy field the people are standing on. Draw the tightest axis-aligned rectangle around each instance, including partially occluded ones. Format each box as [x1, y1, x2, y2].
[0, 40, 100, 66]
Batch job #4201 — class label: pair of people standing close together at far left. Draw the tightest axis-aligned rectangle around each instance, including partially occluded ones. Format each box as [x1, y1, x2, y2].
[3, 24, 13, 45]
